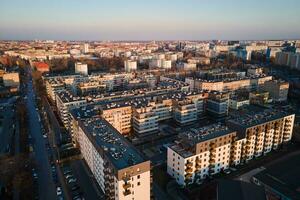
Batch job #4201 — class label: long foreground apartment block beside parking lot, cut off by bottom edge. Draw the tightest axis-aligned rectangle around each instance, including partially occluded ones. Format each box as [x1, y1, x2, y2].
[75, 118, 151, 200]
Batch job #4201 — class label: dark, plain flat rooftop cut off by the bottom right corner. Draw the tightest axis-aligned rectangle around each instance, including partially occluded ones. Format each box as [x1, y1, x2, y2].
[254, 153, 300, 199]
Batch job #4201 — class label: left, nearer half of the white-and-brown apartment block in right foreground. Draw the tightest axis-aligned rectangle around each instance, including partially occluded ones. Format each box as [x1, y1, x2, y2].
[167, 124, 236, 186]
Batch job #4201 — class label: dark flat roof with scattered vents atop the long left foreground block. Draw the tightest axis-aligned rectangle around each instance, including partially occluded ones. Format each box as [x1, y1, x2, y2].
[79, 118, 147, 170]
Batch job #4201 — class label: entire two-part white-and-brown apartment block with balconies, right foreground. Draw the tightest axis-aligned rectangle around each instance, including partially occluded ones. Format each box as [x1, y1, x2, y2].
[167, 108, 295, 186]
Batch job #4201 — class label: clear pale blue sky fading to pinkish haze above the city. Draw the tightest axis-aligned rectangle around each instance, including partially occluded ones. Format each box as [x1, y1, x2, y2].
[0, 0, 300, 40]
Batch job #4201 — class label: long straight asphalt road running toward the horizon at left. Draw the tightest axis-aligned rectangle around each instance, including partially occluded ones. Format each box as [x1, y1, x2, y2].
[26, 69, 57, 200]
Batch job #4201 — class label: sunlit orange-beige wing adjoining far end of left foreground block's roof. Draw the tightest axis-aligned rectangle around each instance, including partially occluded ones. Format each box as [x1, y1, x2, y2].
[100, 102, 132, 135]
